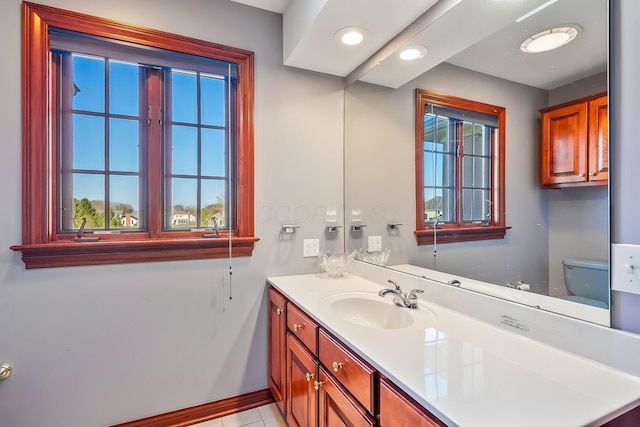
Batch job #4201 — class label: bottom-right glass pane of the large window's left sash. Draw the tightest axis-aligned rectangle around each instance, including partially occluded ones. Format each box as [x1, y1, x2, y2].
[109, 175, 140, 228]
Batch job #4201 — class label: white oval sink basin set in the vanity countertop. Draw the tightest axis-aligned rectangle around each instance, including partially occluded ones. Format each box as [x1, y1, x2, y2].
[323, 291, 432, 329]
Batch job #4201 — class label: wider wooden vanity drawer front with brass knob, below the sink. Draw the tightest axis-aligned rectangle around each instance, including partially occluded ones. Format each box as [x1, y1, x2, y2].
[318, 330, 376, 414]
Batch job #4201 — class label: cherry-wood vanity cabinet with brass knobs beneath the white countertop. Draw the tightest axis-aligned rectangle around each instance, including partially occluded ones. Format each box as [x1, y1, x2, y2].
[269, 288, 442, 427]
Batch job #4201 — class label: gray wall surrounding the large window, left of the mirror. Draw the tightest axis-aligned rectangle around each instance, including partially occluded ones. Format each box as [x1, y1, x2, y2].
[0, 0, 343, 427]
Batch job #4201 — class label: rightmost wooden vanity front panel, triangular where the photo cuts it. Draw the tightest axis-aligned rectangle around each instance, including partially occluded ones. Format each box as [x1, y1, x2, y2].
[379, 379, 445, 427]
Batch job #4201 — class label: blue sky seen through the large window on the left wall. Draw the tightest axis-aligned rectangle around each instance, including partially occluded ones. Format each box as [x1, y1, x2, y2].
[72, 55, 227, 221]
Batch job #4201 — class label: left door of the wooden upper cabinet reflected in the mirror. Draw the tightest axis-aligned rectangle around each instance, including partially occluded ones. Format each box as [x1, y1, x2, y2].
[540, 102, 588, 187]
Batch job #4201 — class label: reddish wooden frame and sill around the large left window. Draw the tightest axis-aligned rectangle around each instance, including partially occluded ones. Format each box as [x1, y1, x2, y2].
[11, 2, 259, 268]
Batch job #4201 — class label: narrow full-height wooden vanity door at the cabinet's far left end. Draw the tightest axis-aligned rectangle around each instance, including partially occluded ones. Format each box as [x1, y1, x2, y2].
[268, 288, 287, 414]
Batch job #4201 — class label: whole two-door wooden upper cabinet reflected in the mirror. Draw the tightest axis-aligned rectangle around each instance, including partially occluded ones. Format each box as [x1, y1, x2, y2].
[540, 93, 609, 188]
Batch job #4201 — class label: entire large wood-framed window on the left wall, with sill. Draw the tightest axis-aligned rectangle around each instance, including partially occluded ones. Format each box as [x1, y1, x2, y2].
[12, 4, 257, 268]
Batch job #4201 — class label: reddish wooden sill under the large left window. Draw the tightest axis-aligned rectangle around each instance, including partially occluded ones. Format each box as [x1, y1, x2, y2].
[11, 237, 260, 269]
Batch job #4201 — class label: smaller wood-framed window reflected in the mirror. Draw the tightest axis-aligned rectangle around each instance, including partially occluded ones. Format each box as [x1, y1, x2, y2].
[415, 89, 509, 244]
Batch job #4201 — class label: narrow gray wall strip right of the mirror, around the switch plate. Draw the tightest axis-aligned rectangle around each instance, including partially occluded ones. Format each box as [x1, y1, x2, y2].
[610, 0, 640, 333]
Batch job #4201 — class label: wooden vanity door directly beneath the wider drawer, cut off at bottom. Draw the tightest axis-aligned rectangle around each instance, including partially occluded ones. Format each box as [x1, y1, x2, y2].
[318, 367, 376, 427]
